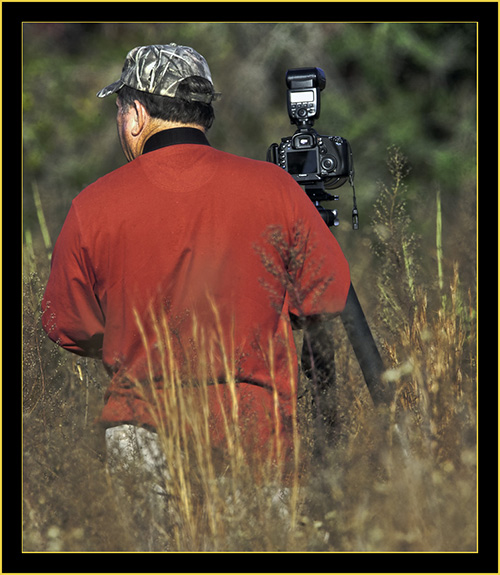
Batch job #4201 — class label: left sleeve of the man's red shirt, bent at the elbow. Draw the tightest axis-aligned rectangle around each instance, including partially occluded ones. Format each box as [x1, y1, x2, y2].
[42, 200, 105, 358]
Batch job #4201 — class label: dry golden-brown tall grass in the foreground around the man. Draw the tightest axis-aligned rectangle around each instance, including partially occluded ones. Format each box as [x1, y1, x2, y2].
[23, 150, 477, 551]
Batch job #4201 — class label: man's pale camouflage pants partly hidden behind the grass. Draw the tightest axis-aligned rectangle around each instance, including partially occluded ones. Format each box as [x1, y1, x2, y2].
[106, 425, 290, 551]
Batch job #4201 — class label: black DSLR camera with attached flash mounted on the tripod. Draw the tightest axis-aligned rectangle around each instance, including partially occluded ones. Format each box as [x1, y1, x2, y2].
[266, 68, 357, 229]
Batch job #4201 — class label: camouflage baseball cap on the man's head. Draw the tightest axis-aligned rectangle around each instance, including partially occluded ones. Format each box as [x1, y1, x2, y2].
[97, 43, 220, 103]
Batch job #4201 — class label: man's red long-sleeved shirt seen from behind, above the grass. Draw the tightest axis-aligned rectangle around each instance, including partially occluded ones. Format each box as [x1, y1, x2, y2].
[42, 134, 350, 464]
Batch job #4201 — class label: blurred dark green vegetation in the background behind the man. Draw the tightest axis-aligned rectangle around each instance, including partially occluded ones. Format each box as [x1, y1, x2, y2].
[23, 23, 476, 297]
